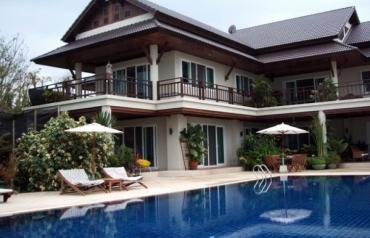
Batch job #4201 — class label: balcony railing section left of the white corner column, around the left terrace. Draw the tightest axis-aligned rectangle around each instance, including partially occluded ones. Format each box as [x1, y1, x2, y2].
[29, 75, 153, 105]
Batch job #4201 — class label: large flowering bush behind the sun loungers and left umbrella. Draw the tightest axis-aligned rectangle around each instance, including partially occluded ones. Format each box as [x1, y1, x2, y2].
[15, 114, 113, 192]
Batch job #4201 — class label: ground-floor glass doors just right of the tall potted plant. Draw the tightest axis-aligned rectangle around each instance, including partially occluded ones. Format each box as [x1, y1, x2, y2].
[202, 125, 225, 166]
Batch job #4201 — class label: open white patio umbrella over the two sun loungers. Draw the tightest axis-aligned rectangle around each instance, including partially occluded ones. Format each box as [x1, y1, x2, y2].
[66, 122, 123, 174]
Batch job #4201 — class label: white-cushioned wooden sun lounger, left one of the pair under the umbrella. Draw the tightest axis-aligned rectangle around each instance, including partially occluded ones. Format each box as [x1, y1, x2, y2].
[58, 169, 105, 195]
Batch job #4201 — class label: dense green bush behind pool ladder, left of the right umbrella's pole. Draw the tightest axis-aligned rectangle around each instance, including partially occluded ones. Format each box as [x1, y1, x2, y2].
[237, 135, 280, 170]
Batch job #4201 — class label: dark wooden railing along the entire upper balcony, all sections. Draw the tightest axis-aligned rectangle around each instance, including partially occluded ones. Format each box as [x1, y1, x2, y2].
[29, 75, 370, 107]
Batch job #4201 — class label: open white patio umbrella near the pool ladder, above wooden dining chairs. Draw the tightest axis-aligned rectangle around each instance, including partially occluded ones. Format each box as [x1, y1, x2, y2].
[257, 122, 309, 171]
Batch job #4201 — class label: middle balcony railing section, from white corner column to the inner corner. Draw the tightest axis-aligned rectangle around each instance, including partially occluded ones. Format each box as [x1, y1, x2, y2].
[157, 77, 250, 105]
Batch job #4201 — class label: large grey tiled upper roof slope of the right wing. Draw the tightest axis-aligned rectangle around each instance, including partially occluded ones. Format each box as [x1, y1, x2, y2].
[232, 7, 355, 49]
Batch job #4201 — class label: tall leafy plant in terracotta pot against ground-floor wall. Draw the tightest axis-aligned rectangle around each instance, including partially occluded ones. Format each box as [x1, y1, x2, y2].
[180, 124, 207, 170]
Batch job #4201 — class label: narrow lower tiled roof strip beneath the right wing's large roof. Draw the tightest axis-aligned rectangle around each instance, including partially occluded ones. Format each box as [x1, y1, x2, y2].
[257, 41, 357, 63]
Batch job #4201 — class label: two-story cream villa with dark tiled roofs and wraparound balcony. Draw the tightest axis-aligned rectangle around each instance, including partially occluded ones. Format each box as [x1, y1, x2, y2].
[25, 0, 370, 170]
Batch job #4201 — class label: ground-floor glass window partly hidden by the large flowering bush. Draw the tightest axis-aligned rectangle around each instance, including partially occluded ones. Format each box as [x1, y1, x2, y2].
[123, 126, 157, 167]
